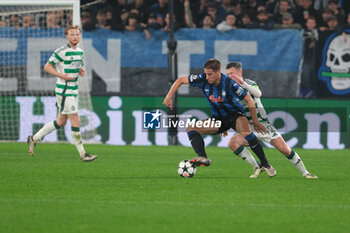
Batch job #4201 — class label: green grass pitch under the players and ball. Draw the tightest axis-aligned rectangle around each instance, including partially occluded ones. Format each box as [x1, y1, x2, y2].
[0, 143, 350, 233]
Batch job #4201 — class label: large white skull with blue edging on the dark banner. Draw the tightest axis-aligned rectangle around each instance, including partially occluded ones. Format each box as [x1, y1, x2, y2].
[318, 30, 350, 95]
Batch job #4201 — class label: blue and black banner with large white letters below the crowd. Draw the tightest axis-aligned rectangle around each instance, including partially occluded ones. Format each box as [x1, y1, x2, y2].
[0, 28, 303, 97]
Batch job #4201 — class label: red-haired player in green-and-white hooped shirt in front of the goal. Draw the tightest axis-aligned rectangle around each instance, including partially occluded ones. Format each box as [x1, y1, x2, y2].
[28, 26, 97, 162]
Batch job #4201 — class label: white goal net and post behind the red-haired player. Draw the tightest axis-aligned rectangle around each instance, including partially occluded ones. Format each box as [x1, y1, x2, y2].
[0, 0, 98, 142]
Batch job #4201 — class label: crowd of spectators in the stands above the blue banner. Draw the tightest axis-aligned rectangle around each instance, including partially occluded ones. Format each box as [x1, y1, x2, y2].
[0, 0, 350, 35]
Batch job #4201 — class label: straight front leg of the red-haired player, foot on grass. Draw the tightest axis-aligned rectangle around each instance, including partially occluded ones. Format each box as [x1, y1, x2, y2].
[68, 114, 97, 162]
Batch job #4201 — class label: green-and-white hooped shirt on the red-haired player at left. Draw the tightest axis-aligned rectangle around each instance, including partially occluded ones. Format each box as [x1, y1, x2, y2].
[48, 44, 84, 96]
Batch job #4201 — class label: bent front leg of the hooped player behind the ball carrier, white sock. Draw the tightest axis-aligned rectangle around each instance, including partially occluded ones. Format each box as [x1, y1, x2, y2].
[228, 134, 264, 178]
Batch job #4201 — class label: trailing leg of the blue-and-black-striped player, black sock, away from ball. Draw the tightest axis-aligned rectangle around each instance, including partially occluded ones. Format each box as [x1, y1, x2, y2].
[236, 116, 277, 177]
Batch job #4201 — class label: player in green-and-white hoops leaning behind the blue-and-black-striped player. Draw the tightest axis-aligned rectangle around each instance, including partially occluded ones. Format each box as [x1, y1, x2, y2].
[226, 62, 318, 179]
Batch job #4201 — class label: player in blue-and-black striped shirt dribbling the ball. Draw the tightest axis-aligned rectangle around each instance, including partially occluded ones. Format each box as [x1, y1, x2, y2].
[163, 59, 276, 177]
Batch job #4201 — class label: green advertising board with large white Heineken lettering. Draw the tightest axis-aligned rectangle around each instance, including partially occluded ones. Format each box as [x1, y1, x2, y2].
[0, 96, 350, 150]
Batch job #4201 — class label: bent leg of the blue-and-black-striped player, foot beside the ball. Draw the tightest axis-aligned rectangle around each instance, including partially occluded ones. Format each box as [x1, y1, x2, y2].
[186, 119, 219, 167]
